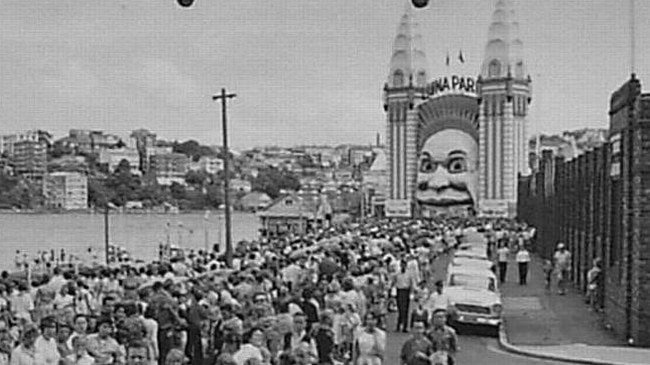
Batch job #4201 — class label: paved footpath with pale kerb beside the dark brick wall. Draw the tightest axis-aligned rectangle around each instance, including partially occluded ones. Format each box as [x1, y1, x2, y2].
[500, 257, 650, 364]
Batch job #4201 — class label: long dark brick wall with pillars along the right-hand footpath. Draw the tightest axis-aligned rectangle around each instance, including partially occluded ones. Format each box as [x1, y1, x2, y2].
[518, 77, 650, 347]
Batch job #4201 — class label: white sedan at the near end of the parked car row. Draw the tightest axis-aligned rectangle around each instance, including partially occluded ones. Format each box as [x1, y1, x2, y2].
[445, 265, 503, 328]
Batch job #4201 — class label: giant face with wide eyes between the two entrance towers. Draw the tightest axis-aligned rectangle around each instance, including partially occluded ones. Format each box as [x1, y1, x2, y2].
[415, 128, 478, 207]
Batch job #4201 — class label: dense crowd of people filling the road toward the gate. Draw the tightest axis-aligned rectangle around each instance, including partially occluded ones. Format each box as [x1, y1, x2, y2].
[0, 219, 532, 365]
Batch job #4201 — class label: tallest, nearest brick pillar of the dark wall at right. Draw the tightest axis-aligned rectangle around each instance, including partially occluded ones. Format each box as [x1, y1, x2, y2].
[606, 75, 650, 343]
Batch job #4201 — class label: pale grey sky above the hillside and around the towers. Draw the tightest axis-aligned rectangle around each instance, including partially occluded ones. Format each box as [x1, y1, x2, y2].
[0, 0, 650, 148]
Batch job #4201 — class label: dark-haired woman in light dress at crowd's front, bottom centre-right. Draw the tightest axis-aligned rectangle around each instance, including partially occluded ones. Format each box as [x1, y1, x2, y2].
[354, 312, 386, 365]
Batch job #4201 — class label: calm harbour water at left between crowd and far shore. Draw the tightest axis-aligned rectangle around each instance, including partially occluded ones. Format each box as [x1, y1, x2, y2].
[0, 211, 260, 270]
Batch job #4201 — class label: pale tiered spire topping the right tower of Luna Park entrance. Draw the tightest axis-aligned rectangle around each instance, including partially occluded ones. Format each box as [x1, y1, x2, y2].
[481, 0, 526, 79]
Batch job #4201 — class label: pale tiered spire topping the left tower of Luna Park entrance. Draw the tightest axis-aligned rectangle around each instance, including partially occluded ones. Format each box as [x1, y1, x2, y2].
[388, 0, 428, 87]
